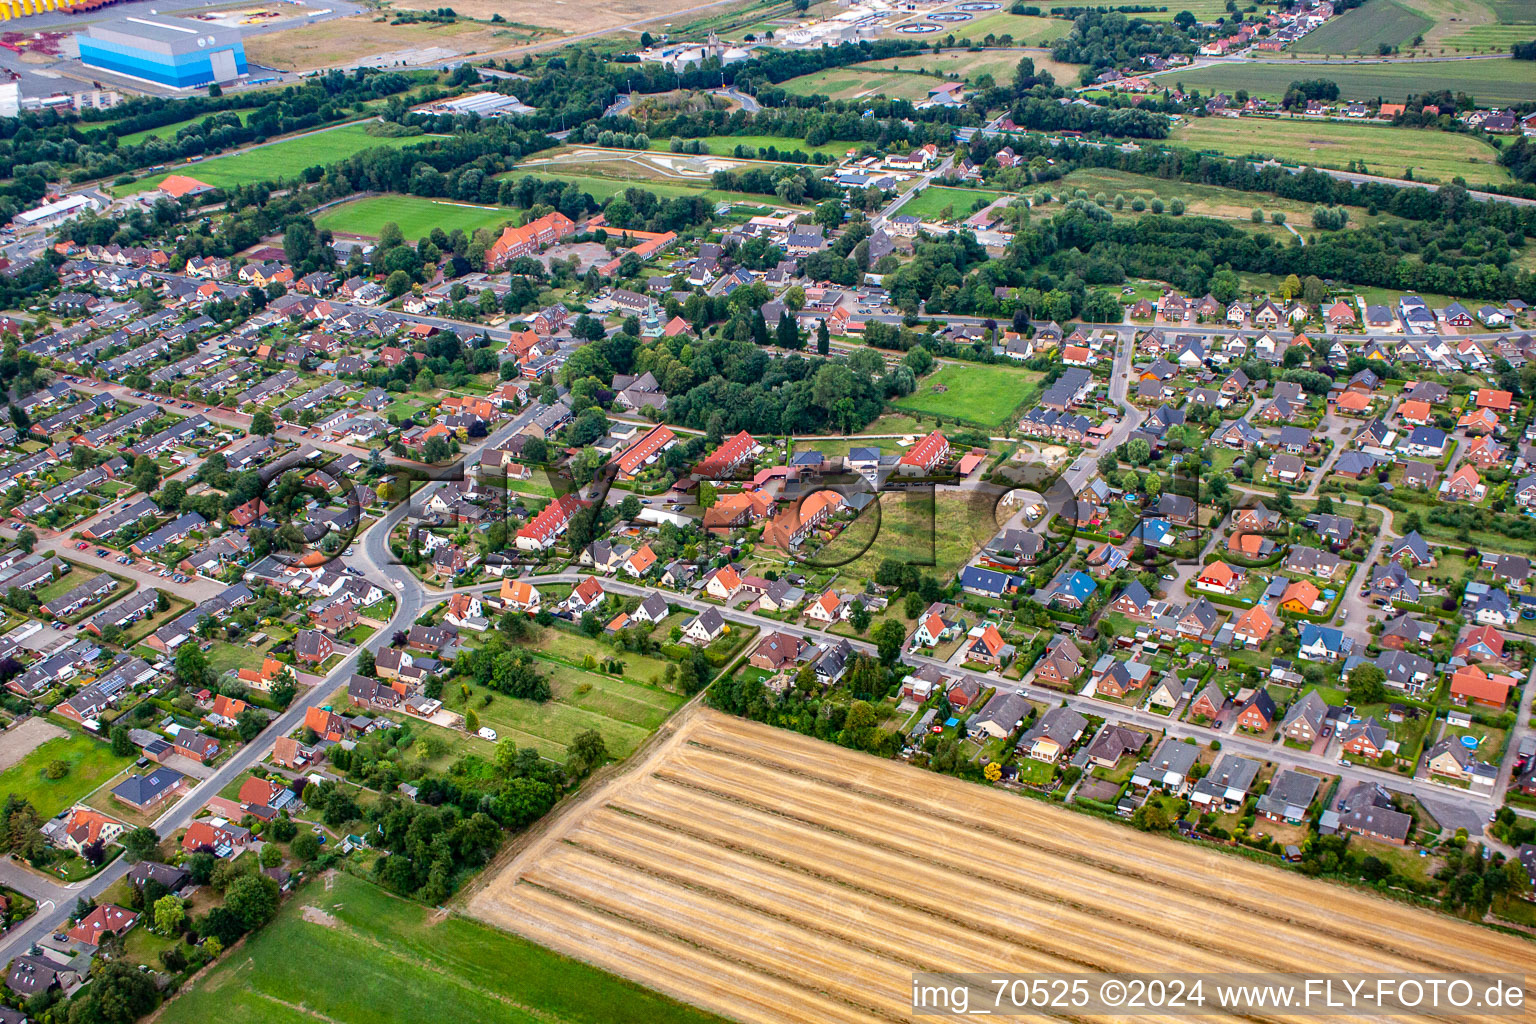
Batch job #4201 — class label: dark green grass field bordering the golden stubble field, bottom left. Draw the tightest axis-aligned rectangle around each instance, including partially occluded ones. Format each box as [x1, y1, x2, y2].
[158, 872, 725, 1024]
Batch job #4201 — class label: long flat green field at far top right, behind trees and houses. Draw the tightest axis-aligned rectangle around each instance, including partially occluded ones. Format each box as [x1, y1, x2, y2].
[1169, 59, 1536, 103]
